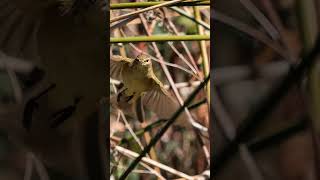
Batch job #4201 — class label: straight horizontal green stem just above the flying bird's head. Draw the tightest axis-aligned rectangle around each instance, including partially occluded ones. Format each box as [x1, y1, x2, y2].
[110, 35, 210, 43]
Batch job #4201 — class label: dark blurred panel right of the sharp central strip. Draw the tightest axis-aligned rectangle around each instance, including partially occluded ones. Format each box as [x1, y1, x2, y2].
[211, 0, 320, 180]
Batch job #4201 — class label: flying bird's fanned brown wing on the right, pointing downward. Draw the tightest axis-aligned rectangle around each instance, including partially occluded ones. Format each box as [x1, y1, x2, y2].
[142, 78, 180, 119]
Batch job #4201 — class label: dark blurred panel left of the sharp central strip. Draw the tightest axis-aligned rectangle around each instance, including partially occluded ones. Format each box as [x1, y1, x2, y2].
[0, 0, 108, 180]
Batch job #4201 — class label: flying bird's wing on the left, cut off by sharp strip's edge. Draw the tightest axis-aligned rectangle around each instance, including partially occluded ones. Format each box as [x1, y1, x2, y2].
[110, 55, 133, 81]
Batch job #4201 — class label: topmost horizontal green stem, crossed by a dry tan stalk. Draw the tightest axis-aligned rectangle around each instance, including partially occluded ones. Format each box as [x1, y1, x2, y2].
[110, 1, 210, 9]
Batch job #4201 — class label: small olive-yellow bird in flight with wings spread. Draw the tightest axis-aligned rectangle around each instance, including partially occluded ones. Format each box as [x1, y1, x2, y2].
[110, 54, 186, 122]
